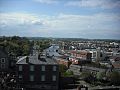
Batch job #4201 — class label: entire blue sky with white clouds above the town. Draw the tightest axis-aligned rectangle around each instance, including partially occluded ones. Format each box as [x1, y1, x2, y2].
[0, 0, 120, 39]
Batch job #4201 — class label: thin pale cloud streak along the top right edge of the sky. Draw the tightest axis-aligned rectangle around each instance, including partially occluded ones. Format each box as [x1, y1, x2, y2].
[65, 0, 120, 9]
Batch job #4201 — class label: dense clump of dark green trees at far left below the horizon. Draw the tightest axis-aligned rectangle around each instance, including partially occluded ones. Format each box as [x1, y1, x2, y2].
[0, 36, 32, 56]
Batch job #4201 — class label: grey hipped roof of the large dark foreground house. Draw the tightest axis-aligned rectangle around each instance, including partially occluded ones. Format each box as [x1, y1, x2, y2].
[16, 56, 58, 65]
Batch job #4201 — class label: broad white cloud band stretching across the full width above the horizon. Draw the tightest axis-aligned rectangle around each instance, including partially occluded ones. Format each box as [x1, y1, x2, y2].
[0, 13, 120, 37]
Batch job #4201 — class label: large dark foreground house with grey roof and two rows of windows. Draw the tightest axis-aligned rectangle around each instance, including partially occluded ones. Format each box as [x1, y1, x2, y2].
[16, 52, 59, 90]
